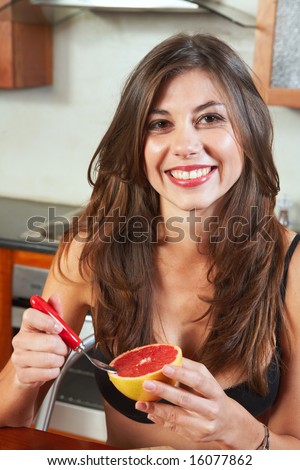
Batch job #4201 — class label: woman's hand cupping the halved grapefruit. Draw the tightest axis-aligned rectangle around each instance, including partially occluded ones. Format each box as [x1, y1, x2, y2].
[136, 359, 261, 449]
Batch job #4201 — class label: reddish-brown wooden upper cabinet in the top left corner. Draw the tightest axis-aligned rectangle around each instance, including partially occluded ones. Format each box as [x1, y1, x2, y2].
[0, 0, 52, 88]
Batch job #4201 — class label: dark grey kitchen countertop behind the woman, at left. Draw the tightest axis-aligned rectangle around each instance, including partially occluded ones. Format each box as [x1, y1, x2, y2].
[0, 197, 80, 254]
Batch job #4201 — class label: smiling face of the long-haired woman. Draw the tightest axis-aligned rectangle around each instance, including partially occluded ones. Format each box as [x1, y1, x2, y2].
[144, 69, 243, 216]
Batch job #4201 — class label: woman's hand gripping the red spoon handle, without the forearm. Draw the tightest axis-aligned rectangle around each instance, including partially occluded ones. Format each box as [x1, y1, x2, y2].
[11, 296, 69, 387]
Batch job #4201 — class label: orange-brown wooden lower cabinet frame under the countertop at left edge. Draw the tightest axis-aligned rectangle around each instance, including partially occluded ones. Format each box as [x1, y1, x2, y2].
[0, 248, 54, 370]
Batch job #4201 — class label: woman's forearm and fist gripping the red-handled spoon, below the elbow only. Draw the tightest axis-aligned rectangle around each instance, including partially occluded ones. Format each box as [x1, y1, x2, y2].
[0, 296, 68, 427]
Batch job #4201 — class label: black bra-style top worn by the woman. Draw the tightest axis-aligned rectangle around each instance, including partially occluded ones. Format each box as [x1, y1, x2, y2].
[95, 234, 300, 424]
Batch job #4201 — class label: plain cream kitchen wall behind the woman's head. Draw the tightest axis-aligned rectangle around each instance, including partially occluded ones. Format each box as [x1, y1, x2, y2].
[0, 0, 300, 228]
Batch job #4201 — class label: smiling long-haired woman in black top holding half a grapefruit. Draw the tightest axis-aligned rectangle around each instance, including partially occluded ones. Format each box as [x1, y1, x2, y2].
[0, 34, 300, 449]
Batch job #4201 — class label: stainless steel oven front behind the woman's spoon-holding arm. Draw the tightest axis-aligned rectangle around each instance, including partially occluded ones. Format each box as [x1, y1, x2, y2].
[12, 264, 107, 441]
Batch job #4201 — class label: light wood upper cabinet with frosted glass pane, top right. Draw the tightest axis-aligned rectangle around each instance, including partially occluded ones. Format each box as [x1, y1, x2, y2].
[253, 0, 300, 108]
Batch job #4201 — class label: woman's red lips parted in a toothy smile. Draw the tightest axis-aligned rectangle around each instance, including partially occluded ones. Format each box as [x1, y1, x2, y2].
[166, 165, 216, 188]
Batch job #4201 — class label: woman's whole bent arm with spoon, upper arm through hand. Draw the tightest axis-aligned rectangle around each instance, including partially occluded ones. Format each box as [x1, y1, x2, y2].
[0, 242, 91, 427]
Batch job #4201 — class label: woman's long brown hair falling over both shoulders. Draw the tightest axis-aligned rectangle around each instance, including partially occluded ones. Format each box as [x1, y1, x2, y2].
[59, 34, 284, 393]
